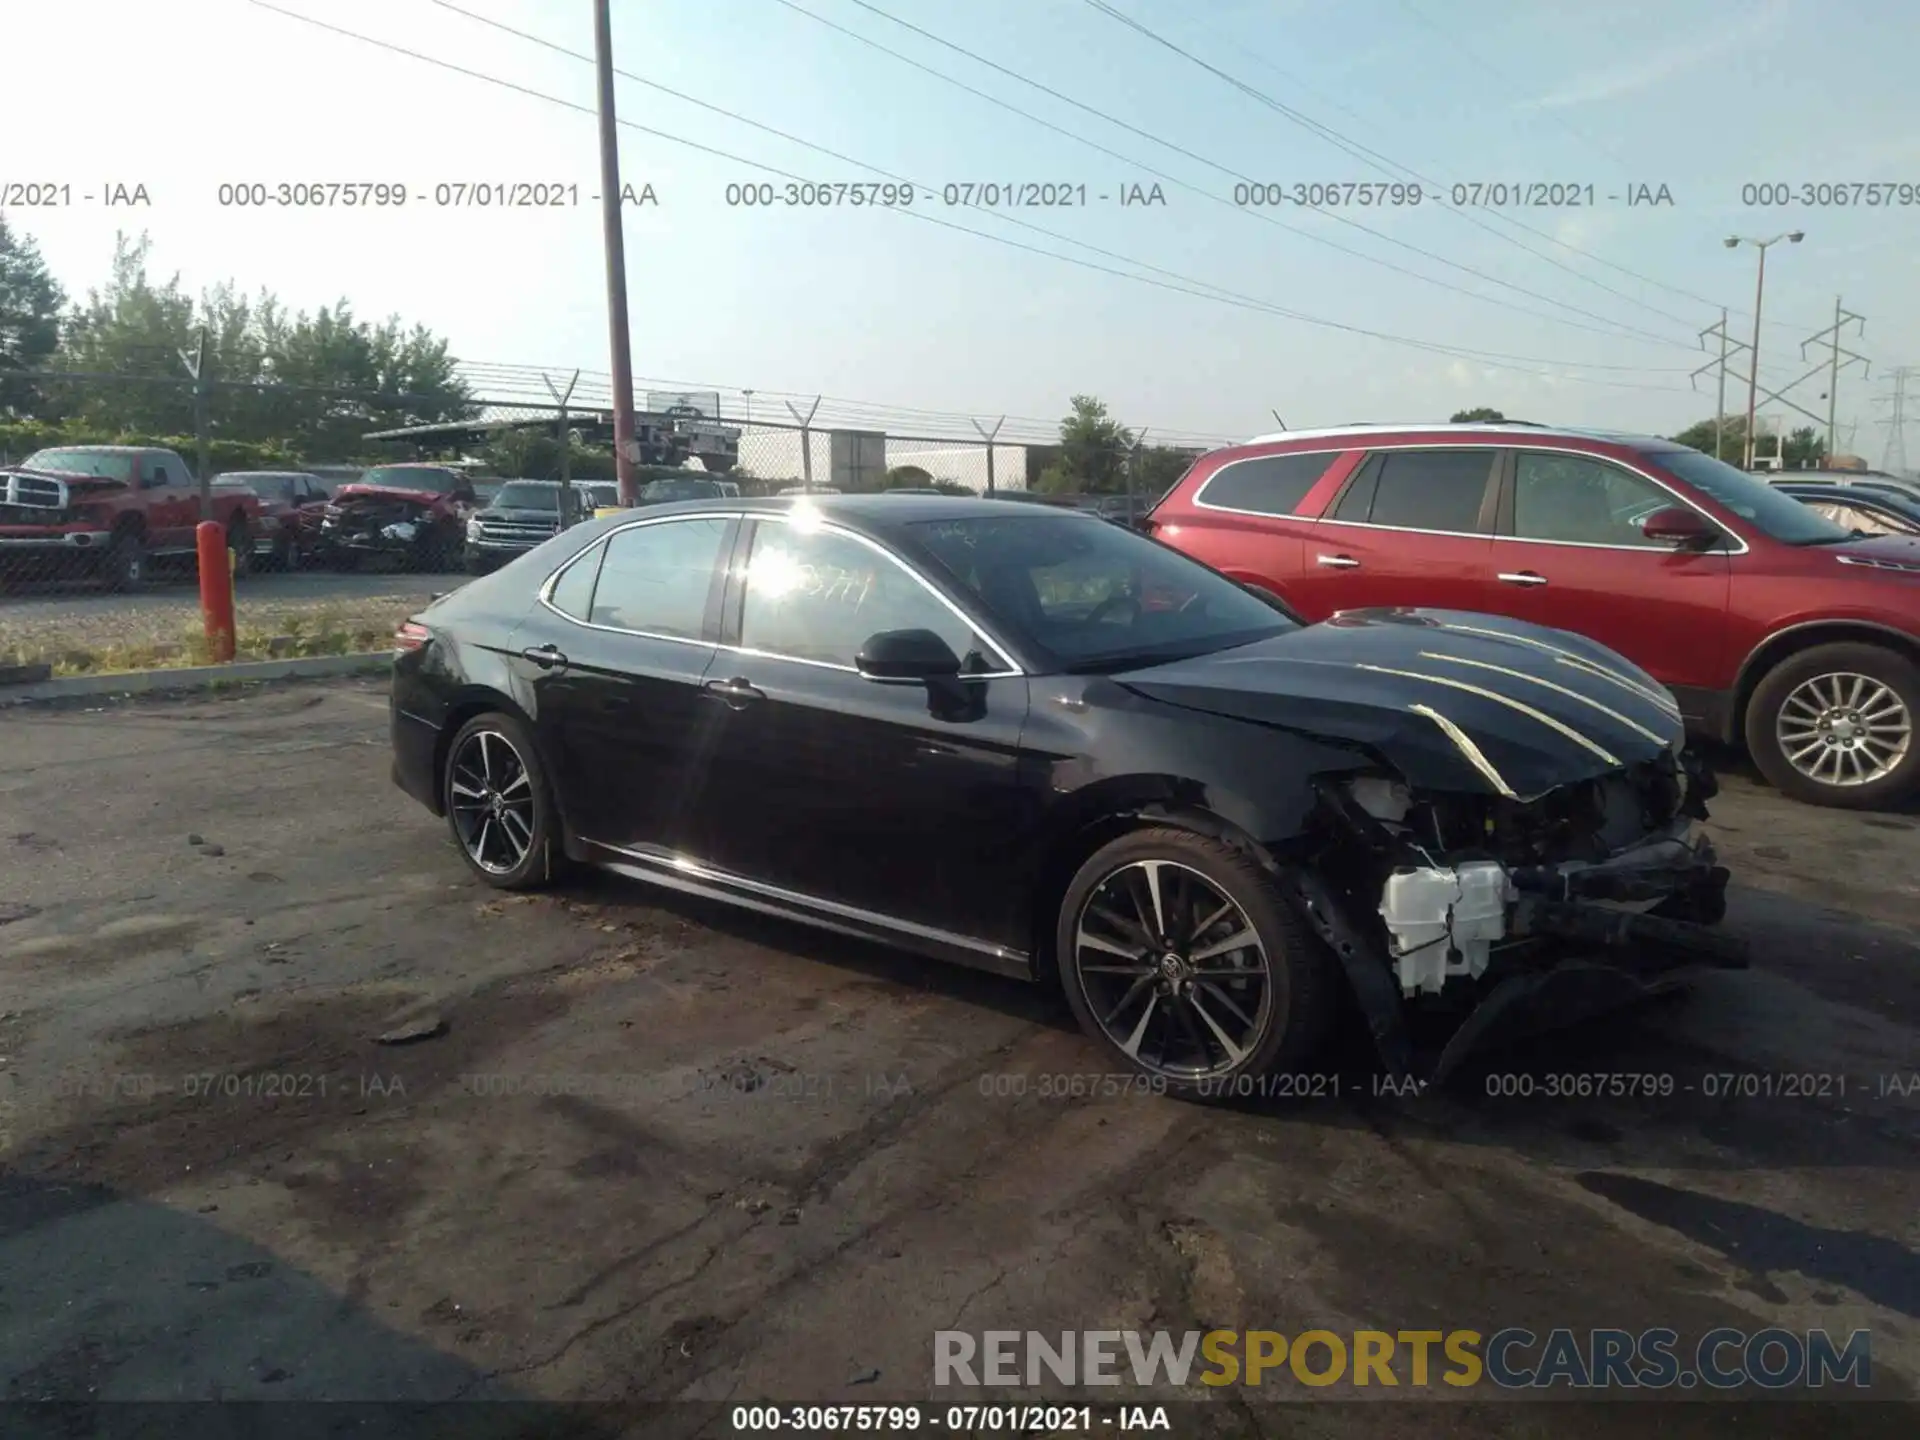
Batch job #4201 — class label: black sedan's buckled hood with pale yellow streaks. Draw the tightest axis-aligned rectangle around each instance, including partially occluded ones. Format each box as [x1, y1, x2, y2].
[1116, 611, 1686, 799]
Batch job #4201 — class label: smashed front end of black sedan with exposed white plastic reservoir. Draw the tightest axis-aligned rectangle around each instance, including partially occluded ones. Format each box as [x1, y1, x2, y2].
[1286, 751, 1747, 1083]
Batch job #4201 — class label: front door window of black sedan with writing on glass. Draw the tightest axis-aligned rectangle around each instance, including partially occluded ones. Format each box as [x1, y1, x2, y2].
[739, 520, 1006, 674]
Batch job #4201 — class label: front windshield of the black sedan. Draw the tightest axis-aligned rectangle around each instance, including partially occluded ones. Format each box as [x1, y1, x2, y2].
[908, 511, 1298, 672]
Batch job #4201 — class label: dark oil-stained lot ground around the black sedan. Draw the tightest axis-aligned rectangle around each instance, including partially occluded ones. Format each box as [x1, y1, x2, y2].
[0, 682, 1920, 1440]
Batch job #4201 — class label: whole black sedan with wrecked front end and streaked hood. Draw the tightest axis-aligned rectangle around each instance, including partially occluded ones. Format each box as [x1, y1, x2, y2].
[392, 495, 1741, 1096]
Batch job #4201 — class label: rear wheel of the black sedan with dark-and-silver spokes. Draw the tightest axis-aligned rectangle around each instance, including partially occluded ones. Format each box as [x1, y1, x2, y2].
[442, 710, 564, 891]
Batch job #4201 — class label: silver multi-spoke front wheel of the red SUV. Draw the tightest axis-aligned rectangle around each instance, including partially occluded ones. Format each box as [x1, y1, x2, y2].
[1745, 641, 1920, 810]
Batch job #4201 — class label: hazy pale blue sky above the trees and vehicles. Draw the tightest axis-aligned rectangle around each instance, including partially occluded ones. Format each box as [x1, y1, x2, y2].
[0, 0, 1920, 459]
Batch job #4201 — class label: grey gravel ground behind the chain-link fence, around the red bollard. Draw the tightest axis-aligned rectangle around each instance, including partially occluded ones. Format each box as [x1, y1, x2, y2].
[0, 570, 467, 657]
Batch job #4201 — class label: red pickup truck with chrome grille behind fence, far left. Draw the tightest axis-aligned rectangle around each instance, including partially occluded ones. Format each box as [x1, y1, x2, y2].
[0, 445, 267, 589]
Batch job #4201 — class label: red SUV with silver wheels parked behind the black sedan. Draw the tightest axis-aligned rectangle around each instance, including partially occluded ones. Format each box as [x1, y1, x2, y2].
[1146, 424, 1920, 808]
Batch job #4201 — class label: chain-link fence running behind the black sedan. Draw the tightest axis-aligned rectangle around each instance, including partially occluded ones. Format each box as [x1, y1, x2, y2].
[0, 376, 1198, 674]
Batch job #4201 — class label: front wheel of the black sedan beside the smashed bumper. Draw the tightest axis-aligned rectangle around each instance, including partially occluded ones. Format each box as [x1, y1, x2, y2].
[1054, 828, 1331, 1100]
